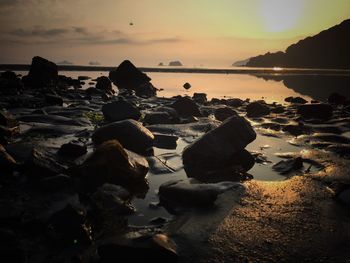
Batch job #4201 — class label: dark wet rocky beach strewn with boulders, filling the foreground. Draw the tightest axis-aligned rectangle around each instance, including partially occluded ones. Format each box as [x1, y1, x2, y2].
[0, 57, 350, 262]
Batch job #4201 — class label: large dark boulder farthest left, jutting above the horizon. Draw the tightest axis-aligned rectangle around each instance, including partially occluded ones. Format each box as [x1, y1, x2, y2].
[24, 57, 58, 88]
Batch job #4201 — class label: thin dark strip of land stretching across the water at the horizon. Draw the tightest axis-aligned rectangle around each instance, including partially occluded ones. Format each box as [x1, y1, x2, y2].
[0, 64, 350, 75]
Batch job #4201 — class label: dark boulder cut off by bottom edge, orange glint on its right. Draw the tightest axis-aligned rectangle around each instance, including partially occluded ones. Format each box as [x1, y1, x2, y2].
[97, 232, 178, 263]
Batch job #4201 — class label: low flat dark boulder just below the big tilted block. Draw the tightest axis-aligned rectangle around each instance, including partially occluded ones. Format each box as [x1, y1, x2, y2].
[159, 178, 242, 210]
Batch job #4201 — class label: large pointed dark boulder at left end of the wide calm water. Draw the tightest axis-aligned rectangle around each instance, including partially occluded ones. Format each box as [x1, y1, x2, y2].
[109, 60, 157, 97]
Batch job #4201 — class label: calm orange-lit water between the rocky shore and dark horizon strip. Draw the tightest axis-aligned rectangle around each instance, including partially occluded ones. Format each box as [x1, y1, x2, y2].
[54, 71, 350, 102]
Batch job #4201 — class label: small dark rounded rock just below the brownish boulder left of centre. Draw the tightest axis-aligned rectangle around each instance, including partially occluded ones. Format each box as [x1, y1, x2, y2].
[91, 184, 135, 215]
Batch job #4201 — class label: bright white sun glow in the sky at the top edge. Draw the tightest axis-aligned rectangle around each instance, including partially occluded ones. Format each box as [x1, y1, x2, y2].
[261, 0, 305, 32]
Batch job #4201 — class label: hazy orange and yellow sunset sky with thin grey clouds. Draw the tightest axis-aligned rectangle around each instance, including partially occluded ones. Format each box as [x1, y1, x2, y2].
[0, 0, 350, 67]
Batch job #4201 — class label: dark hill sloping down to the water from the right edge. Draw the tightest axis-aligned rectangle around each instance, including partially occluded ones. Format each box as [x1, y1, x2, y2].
[246, 19, 350, 69]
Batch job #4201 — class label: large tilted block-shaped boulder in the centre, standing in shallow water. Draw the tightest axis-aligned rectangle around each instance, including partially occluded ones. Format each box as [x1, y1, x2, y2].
[182, 116, 256, 182]
